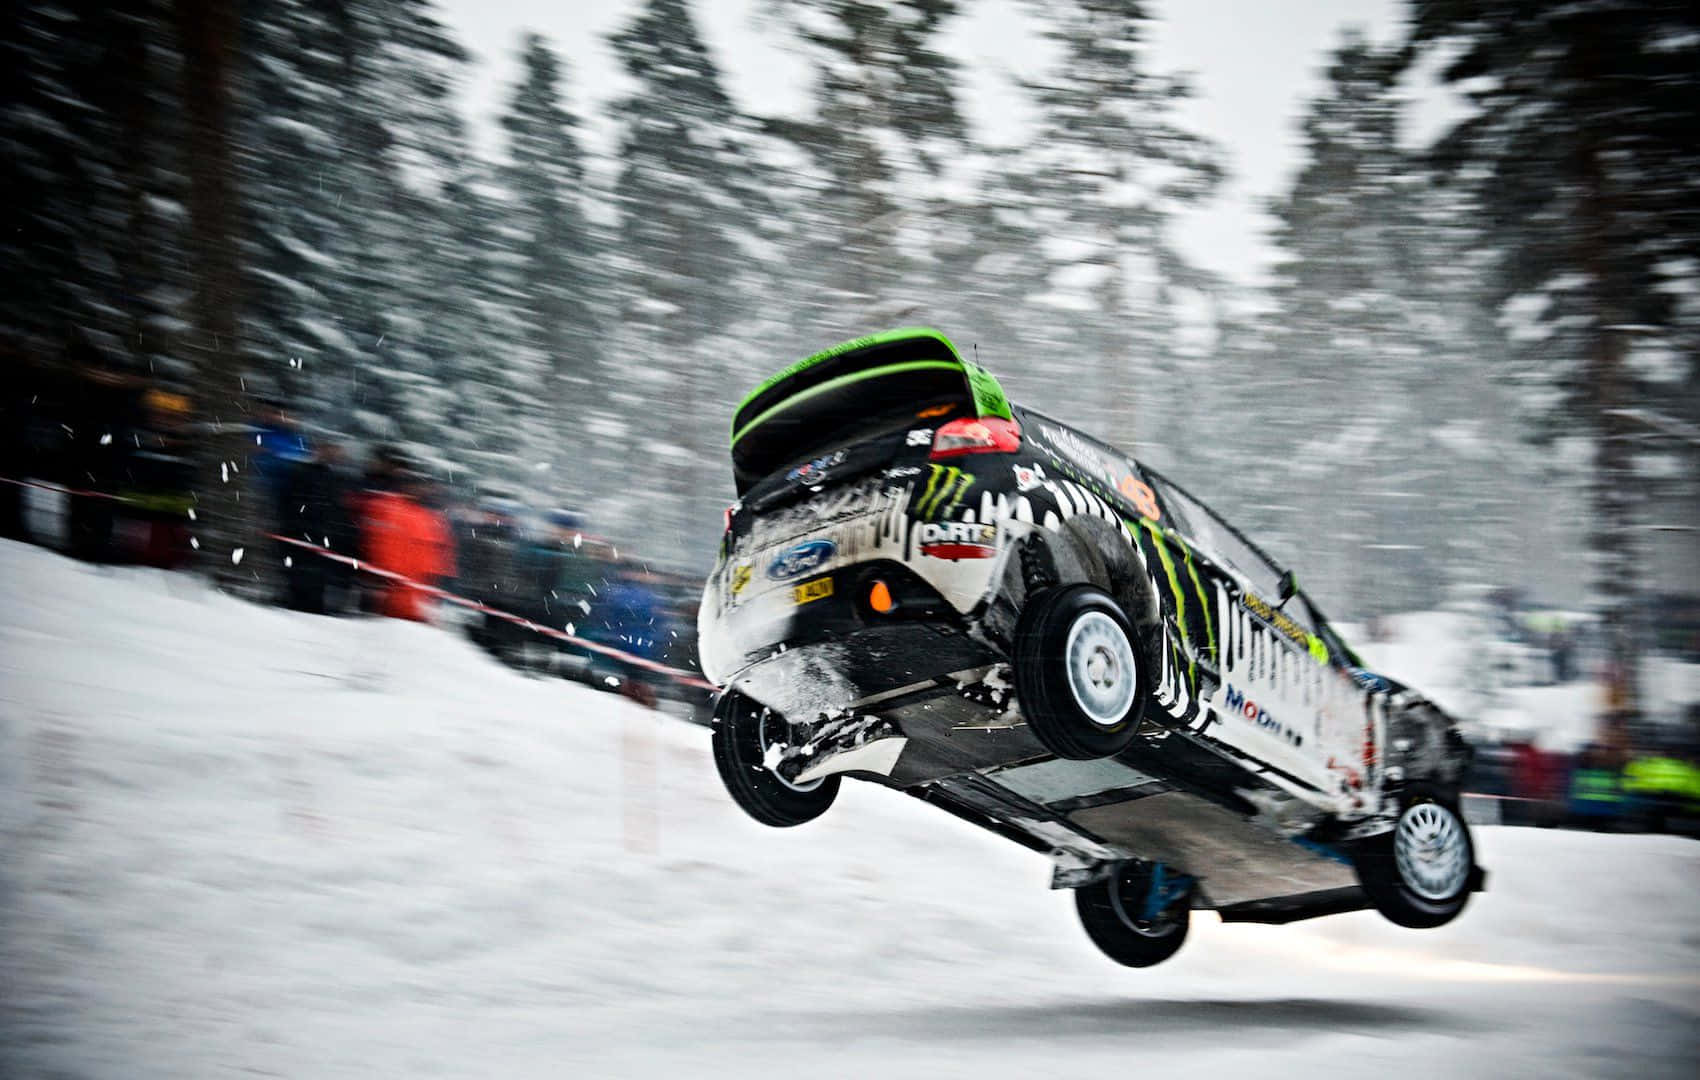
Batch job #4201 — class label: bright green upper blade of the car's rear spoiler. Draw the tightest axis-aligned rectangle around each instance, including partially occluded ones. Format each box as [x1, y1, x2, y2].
[731, 327, 1013, 459]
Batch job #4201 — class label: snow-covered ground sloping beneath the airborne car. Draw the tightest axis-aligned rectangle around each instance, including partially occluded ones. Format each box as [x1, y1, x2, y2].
[0, 543, 1700, 1080]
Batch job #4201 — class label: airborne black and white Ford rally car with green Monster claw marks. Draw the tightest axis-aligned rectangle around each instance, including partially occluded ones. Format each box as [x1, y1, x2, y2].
[699, 328, 1482, 966]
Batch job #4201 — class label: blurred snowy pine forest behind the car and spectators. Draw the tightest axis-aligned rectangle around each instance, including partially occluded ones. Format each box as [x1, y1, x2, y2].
[0, 0, 1700, 642]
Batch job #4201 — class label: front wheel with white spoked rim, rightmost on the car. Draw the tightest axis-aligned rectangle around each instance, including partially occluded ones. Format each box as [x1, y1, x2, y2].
[1353, 786, 1476, 930]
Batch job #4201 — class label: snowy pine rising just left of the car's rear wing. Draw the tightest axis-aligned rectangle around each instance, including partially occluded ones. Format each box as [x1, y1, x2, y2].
[592, 0, 777, 556]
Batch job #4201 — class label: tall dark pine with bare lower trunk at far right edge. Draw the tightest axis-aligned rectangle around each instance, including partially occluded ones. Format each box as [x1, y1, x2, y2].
[1414, 0, 1700, 727]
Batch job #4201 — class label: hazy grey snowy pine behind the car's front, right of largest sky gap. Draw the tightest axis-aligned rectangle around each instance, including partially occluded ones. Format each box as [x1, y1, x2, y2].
[1241, 34, 1550, 612]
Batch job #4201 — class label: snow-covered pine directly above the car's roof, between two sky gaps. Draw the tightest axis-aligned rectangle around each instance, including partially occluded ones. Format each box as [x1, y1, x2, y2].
[1025, 0, 1221, 454]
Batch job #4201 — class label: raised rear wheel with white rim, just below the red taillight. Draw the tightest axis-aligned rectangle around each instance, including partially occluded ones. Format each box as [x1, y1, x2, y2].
[1013, 585, 1148, 760]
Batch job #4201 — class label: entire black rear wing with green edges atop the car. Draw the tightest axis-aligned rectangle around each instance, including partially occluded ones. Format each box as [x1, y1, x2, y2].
[731, 327, 1013, 492]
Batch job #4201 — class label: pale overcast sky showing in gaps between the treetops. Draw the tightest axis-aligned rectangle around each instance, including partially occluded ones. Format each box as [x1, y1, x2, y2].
[439, 0, 1421, 282]
